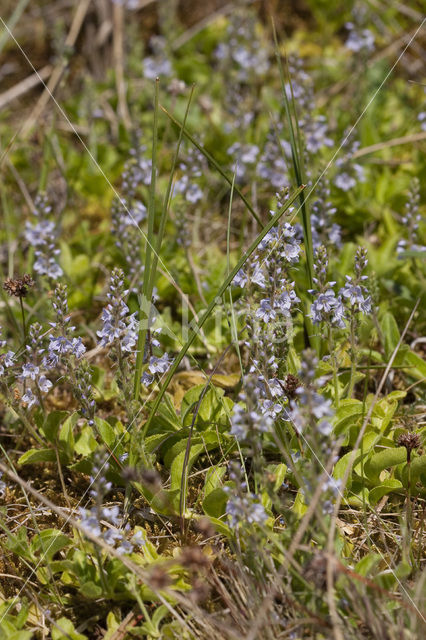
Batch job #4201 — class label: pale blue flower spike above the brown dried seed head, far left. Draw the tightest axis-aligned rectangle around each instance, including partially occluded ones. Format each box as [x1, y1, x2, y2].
[24, 193, 63, 280]
